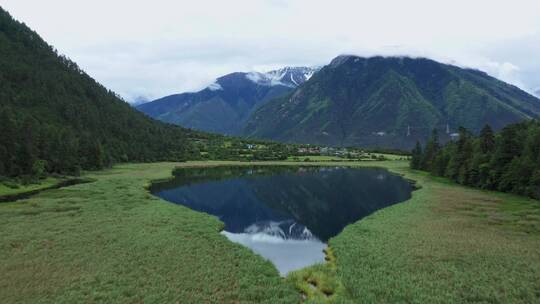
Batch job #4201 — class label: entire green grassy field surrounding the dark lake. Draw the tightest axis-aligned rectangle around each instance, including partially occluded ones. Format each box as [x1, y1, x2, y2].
[0, 161, 540, 303]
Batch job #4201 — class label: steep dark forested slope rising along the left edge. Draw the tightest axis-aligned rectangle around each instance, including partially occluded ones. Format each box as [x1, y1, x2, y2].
[0, 8, 198, 177]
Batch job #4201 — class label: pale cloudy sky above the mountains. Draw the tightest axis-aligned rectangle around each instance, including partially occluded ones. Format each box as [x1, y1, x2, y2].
[0, 0, 540, 101]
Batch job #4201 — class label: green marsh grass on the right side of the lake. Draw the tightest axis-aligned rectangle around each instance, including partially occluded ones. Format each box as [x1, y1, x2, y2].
[295, 162, 540, 303]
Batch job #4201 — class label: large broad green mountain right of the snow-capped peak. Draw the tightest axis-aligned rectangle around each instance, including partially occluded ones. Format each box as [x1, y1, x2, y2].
[244, 56, 540, 149]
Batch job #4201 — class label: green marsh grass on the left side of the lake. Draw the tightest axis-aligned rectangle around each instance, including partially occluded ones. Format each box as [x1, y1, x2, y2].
[0, 163, 300, 303]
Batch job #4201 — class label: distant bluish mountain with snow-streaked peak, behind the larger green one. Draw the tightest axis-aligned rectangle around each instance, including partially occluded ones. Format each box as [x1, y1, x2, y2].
[136, 67, 317, 135]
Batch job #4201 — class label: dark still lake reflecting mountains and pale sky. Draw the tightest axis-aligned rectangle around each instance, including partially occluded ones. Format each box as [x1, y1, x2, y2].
[151, 166, 412, 275]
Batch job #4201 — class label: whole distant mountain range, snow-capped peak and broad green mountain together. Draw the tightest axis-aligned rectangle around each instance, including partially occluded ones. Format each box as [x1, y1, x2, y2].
[137, 55, 540, 149]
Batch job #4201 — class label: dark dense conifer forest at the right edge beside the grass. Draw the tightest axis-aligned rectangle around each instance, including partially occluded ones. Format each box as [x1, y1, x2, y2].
[411, 121, 540, 198]
